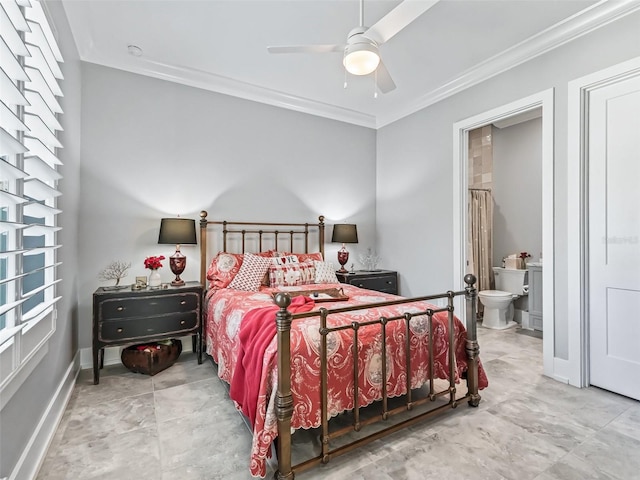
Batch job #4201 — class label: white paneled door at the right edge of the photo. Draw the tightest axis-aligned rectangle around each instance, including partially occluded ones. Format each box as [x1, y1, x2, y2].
[588, 76, 640, 400]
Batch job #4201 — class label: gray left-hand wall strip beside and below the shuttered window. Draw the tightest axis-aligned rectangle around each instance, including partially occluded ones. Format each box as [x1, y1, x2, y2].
[0, 2, 81, 477]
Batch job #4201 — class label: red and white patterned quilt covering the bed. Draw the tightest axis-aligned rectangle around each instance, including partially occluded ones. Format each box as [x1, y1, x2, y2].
[205, 284, 488, 477]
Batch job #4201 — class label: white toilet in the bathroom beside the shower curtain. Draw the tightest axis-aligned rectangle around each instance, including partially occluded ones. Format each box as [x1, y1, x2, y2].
[478, 267, 528, 330]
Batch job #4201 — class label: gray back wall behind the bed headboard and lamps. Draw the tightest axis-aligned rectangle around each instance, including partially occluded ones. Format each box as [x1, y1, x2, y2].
[78, 63, 376, 347]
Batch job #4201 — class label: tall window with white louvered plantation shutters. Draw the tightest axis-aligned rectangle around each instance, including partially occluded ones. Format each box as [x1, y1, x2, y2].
[0, 0, 62, 390]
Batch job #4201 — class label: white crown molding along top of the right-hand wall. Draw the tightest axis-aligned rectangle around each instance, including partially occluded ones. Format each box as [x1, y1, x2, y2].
[376, 0, 640, 128]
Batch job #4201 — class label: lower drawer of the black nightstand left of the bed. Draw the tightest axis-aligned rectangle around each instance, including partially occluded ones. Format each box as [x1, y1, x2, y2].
[98, 312, 199, 342]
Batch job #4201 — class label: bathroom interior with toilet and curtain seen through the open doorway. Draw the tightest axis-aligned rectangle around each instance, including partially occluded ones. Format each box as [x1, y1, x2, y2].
[466, 112, 543, 330]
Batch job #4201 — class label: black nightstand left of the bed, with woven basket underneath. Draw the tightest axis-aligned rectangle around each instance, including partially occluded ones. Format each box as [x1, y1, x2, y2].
[93, 282, 203, 385]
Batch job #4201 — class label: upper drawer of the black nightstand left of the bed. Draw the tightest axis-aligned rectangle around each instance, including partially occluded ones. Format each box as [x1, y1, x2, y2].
[100, 292, 200, 320]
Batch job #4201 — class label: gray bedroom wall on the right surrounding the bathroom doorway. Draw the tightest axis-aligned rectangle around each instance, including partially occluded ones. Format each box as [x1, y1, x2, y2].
[377, 13, 640, 359]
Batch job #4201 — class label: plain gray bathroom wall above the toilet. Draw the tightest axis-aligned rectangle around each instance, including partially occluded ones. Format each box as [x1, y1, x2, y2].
[492, 118, 542, 267]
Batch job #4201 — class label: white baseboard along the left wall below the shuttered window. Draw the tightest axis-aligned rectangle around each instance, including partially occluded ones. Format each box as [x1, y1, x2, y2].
[8, 353, 80, 480]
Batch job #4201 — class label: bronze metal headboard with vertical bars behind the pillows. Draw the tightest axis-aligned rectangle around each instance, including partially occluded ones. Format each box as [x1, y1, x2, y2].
[200, 210, 325, 285]
